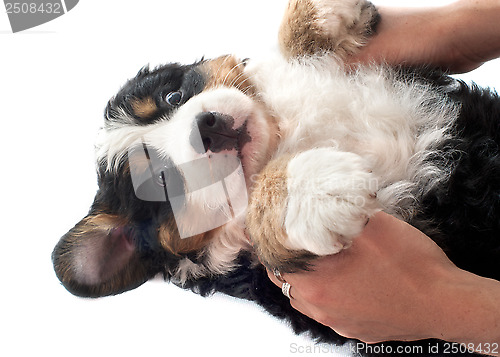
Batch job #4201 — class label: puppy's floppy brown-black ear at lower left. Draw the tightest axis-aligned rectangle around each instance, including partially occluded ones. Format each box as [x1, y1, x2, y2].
[52, 213, 156, 297]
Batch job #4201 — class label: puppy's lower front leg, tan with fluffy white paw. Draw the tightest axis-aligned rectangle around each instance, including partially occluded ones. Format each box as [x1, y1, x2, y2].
[247, 148, 379, 271]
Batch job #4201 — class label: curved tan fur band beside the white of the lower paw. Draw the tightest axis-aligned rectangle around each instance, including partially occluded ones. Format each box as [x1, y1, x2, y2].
[246, 156, 313, 272]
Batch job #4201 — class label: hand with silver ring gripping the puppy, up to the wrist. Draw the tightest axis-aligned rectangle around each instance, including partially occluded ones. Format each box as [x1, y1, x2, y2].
[269, 213, 456, 343]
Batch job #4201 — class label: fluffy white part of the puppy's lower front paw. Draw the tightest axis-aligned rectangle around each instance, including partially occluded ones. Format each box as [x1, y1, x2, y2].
[285, 148, 380, 255]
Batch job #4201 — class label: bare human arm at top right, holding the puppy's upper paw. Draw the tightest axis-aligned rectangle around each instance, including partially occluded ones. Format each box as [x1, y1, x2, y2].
[349, 0, 500, 73]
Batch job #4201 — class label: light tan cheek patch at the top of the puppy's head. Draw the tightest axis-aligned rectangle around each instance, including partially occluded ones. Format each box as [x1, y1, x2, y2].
[201, 56, 255, 95]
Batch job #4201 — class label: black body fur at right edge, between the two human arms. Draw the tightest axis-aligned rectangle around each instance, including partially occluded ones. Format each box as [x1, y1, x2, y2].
[411, 82, 500, 280]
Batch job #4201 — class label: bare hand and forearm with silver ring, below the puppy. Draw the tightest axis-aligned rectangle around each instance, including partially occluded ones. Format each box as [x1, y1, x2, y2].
[269, 212, 500, 356]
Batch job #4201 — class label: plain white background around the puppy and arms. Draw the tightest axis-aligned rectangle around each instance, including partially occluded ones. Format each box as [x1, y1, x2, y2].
[0, 0, 500, 357]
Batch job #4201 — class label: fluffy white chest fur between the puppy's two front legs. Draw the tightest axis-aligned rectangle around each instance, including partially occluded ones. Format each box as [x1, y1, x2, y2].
[250, 58, 458, 209]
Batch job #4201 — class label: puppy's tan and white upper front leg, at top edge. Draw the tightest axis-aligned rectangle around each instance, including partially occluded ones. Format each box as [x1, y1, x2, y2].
[279, 0, 379, 60]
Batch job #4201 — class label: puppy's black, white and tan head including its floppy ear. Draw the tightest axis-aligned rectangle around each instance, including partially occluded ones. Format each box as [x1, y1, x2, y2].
[53, 56, 276, 296]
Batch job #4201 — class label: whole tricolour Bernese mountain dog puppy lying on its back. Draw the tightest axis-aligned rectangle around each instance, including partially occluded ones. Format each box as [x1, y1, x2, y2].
[52, 0, 500, 354]
